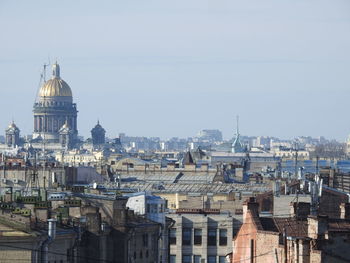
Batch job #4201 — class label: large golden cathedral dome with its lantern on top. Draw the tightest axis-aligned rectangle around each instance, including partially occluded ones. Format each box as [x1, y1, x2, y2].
[39, 63, 72, 97]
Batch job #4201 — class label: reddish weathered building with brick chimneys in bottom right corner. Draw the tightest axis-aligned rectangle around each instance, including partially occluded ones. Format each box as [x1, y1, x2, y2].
[231, 198, 350, 263]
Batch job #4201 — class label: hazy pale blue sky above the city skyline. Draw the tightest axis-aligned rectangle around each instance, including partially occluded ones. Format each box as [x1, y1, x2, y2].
[0, 0, 350, 140]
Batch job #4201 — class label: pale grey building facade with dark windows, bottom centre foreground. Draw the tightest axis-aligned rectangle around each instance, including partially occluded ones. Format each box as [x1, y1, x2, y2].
[167, 212, 233, 263]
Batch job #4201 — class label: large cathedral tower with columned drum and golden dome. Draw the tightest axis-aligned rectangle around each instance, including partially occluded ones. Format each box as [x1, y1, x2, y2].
[33, 62, 78, 143]
